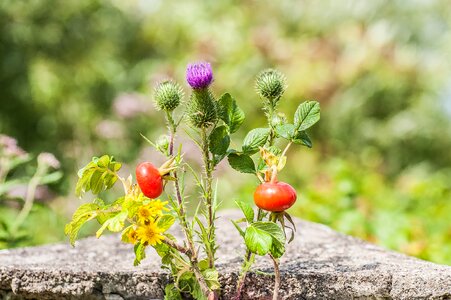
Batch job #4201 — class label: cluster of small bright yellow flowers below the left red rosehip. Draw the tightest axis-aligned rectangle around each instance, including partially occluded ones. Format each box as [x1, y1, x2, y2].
[127, 200, 169, 246]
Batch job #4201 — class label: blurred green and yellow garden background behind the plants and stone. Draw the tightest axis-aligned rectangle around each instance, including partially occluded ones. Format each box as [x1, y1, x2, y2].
[0, 0, 451, 264]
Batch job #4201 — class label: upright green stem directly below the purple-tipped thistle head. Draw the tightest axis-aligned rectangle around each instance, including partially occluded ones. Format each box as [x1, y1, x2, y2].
[201, 127, 215, 268]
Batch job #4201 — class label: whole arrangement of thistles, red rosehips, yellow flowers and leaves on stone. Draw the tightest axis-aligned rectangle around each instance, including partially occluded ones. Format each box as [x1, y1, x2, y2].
[65, 63, 320, 299]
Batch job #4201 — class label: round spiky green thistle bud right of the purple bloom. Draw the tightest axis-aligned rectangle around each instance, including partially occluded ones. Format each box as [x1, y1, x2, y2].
[255, 69, 287, 106]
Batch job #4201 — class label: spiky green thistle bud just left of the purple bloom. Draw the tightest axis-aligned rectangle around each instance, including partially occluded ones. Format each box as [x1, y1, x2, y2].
[155, 80, 183, 111]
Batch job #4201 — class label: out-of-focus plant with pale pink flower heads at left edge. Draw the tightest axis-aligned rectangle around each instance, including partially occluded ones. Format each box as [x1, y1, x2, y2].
[0, 134, 62, 249]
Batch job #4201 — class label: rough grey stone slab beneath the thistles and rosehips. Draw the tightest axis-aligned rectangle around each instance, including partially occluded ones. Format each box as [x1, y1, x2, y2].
[0, 211, 451, 300]
